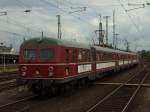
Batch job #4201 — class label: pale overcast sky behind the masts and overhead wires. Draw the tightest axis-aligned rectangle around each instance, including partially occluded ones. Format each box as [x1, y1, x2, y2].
[0, 0, 150, 51]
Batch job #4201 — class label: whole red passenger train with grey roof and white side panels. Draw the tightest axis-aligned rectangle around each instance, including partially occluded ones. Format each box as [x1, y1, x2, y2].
[19, 37, 139, 92]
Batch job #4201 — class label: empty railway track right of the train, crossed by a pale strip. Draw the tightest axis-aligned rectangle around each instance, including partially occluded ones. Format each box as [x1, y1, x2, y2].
[86, 70, 149, 112]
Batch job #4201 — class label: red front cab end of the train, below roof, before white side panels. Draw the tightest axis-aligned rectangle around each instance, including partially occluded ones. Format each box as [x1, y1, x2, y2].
[19, 46, 83, 83]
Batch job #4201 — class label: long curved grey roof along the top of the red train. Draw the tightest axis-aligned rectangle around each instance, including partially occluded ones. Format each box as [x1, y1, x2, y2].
[21, 37, 137, 55]
